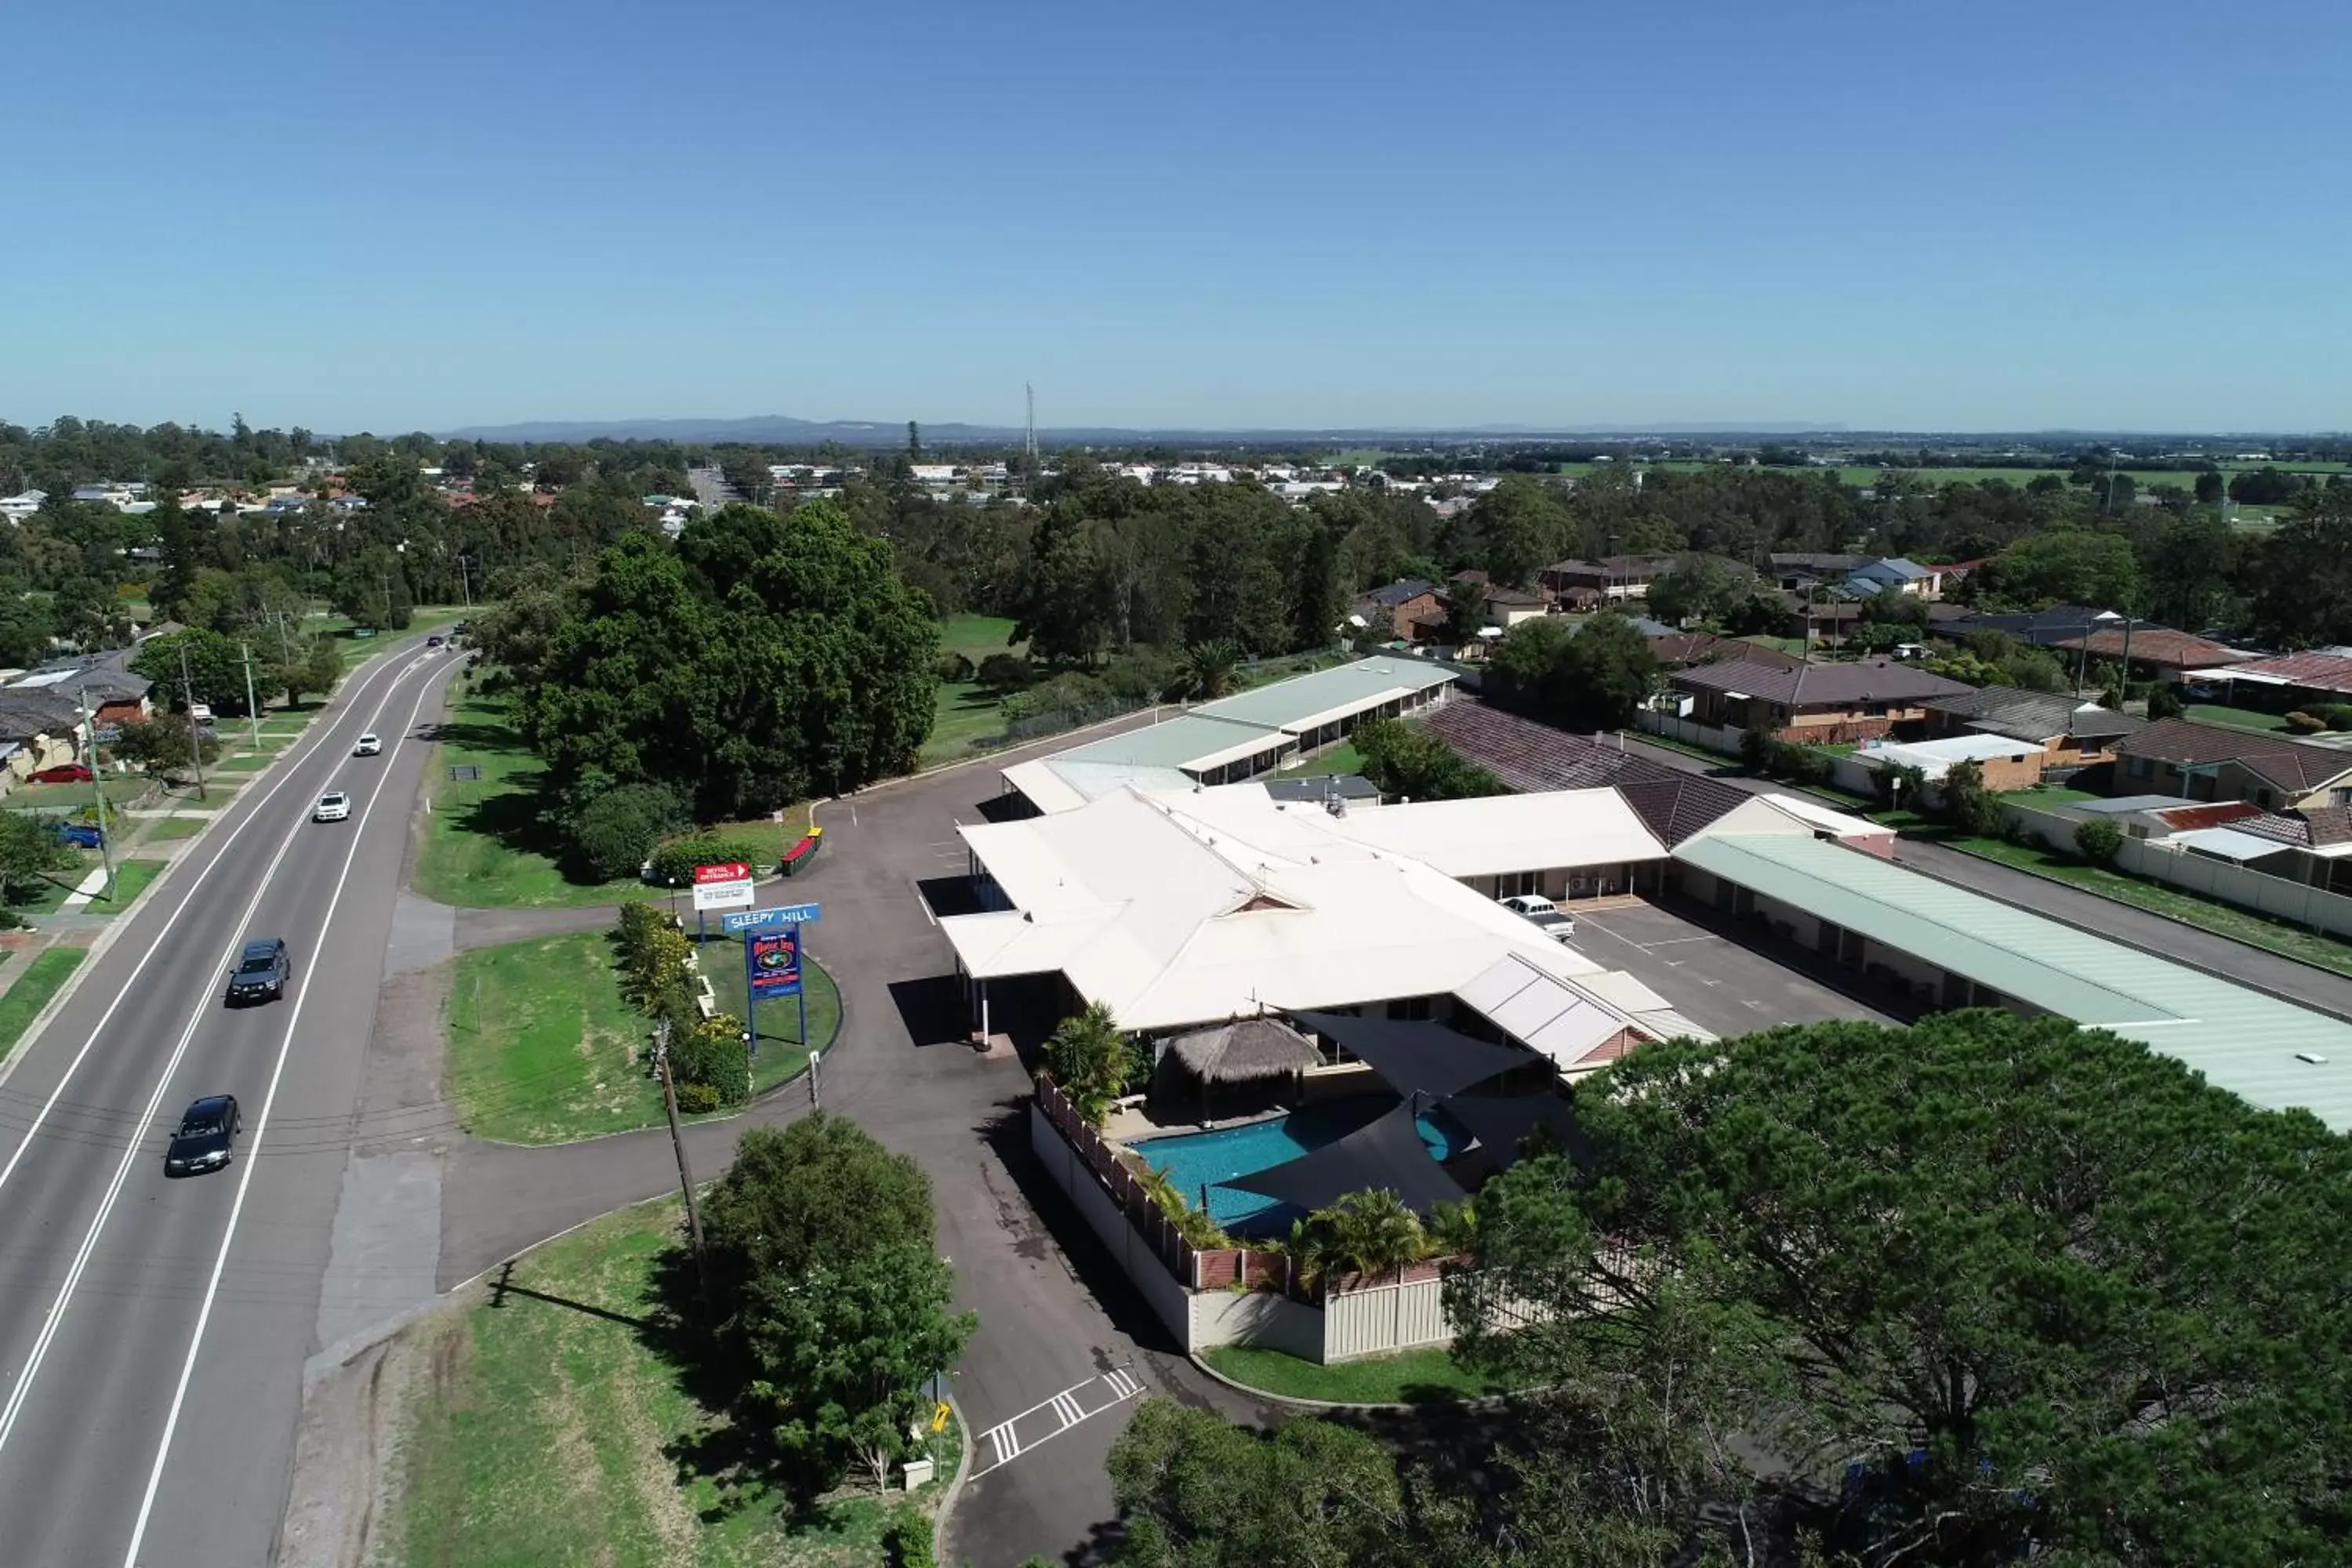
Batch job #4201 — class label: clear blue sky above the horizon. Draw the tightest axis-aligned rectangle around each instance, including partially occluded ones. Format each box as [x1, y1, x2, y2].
[0, 0, 2352, 430]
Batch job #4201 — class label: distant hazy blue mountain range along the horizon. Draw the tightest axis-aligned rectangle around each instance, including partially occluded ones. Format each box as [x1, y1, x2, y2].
[442, 414, 1846, 447]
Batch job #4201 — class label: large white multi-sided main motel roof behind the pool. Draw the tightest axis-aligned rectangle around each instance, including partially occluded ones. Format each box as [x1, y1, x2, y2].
[938, 785, 1653, 1039]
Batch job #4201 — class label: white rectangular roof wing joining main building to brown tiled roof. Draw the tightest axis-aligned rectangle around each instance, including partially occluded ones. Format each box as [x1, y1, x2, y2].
[1331, 787, 1665, 877]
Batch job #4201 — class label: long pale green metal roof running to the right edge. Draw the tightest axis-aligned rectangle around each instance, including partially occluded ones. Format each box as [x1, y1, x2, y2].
[1675, 832, 2352, 1133]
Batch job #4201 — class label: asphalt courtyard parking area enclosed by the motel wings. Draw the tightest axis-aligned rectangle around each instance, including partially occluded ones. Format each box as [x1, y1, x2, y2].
[1576, 902, 1900, 1036]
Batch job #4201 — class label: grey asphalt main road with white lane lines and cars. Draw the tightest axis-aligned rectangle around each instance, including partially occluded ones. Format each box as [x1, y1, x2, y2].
[0, 642, 454, 1568]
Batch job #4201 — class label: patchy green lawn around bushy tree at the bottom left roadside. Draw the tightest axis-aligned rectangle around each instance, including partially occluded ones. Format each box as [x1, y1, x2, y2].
[379, 1199, 962, 1568]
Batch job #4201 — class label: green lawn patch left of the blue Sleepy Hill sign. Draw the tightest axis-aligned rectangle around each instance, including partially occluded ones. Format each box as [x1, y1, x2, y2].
[447, 931, 661, 1142]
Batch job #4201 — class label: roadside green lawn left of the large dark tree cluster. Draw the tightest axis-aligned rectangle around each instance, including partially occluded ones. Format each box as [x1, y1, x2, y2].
[416, 696, 649, 909]
